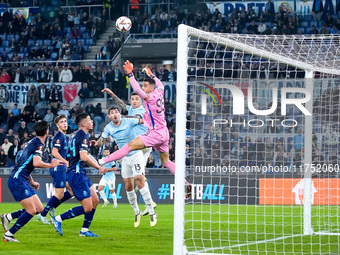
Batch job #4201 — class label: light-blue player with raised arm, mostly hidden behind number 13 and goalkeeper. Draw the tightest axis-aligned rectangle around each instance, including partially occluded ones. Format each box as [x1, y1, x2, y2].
[102, 88, 157, 216]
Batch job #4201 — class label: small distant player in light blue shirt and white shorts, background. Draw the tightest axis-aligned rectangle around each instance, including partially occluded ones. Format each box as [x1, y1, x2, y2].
[98, 148, 118, 208]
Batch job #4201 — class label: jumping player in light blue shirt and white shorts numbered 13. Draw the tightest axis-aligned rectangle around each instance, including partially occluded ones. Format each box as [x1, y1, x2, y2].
[91, 106, 157, 228]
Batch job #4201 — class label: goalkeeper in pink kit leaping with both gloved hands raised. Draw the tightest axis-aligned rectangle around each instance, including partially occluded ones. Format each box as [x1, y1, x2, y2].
[99, 61, 191, 198]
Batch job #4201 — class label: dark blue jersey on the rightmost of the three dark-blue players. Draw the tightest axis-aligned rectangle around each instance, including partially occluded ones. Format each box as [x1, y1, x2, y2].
[67, 129, 89, 173]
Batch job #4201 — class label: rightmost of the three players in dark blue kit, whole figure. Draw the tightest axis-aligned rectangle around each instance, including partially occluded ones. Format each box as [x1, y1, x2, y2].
[51, 113, 107, 237]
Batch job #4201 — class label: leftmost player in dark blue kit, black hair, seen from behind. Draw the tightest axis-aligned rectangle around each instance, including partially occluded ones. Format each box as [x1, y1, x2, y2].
[1, 121, 61, 242]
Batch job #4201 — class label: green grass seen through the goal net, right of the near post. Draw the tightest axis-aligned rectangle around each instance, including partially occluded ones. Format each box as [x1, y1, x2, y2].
[185, 204, 340, 255]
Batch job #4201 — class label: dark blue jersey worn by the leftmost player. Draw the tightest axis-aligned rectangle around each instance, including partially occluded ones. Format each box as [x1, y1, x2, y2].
[12, 137, 45, 180]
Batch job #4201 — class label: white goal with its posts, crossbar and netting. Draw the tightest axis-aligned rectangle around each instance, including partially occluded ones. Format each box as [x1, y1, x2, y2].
[174, 25, 340, 255]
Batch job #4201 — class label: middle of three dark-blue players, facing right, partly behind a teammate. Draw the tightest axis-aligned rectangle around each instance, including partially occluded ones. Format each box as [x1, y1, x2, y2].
[37, 114, 73, 224]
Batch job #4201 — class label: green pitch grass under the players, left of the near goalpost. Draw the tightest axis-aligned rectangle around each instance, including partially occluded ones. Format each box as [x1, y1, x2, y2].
[0, 203, 173, 255]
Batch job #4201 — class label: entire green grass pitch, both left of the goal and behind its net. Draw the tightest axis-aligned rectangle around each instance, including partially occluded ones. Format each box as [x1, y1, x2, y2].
[0, 203, 340, 255]
